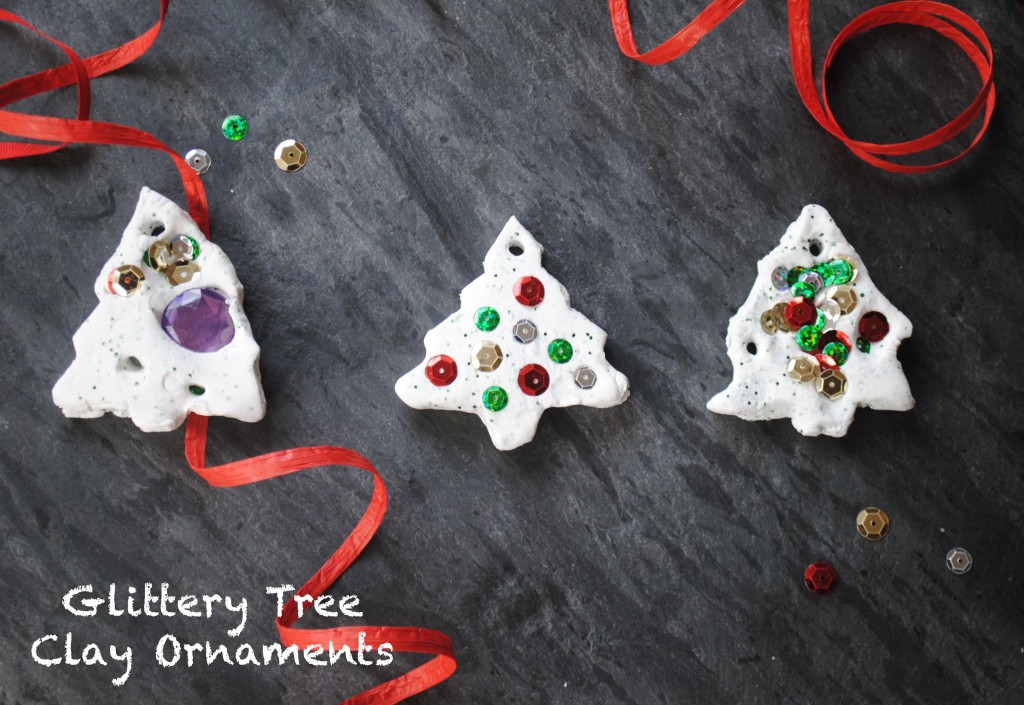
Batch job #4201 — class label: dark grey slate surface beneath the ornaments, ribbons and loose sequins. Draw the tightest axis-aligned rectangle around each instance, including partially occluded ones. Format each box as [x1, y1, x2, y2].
[0, 0, 1024, 705]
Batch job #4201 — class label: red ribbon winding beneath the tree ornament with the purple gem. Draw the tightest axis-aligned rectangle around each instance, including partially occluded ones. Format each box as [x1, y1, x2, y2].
[0, 0, 456, 705]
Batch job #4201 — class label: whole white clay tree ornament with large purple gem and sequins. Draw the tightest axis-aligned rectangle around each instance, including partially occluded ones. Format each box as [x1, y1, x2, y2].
[53, 189, 266, 431]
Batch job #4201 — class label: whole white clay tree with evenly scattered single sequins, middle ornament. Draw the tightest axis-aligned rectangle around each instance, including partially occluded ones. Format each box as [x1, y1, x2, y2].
[395, 217, 630, 451]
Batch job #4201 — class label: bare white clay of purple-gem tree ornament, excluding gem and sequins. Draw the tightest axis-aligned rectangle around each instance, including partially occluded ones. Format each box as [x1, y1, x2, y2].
[53, 189, 266, 431]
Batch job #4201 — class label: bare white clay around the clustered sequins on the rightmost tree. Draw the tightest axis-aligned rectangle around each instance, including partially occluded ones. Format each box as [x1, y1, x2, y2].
[708, 206, 913, 437]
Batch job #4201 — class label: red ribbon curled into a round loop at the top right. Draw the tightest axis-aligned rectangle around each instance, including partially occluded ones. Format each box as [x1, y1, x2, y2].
[608, 0, 995, 174]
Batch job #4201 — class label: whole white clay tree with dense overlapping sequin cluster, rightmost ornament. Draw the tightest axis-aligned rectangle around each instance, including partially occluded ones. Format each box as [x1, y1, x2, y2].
[708, 206, 913, 437]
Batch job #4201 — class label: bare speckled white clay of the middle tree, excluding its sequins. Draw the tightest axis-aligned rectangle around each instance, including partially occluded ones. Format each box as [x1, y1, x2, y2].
[395, 217, 630, 450]
